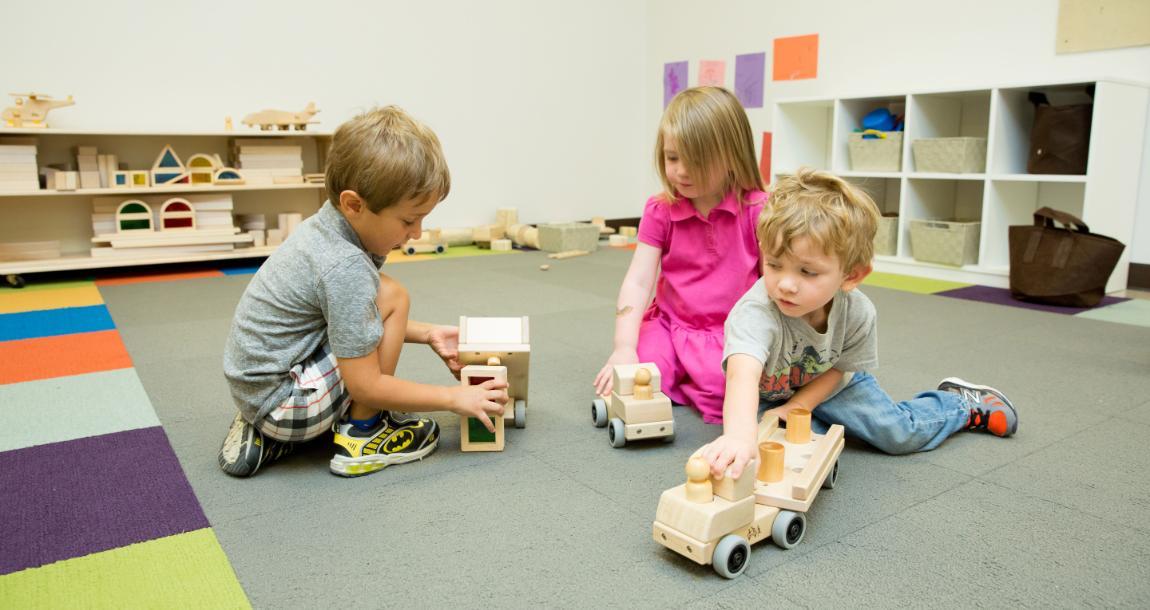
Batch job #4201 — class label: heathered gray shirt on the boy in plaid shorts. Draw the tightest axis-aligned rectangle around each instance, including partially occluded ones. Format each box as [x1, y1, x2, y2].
[223, 201, 386, 421]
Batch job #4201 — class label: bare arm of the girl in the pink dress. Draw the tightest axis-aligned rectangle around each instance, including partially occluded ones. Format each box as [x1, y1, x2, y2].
[595, 242, 662, 395]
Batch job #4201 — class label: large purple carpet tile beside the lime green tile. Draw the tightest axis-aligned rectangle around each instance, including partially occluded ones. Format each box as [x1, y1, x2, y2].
[0, 422, 208, 574]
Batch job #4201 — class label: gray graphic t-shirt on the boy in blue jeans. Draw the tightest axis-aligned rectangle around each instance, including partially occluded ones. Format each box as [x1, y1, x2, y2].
[722, 279, 879, 402]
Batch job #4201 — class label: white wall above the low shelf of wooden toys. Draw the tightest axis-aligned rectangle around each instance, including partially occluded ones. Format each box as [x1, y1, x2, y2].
[0, 0, 649, 227]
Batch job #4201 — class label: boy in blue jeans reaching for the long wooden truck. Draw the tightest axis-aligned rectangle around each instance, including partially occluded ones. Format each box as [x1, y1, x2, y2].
[703, 169, 1018, 479]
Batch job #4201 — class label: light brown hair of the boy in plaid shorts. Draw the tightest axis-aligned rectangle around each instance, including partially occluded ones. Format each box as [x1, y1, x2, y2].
[324, 106, 451, 213]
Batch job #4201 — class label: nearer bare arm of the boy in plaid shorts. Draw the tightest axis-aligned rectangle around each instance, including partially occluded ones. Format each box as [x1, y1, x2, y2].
[339, 352, 507, 432]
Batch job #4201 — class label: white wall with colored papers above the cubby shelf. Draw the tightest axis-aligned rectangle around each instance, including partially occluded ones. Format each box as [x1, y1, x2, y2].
[644, 0, 1150, 264]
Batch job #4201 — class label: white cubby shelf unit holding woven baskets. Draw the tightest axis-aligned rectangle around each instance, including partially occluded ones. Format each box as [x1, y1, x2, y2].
[771, 79, 1150, 292]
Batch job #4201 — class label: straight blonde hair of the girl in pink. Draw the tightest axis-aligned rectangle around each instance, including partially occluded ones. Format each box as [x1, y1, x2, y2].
[654, 86, 764, 203]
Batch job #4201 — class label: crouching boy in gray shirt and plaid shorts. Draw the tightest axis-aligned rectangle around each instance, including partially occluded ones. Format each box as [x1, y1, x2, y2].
[220, 106, 507, 476]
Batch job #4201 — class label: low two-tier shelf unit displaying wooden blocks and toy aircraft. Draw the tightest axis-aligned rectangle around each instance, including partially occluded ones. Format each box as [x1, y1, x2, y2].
[0, 129, 331, 276]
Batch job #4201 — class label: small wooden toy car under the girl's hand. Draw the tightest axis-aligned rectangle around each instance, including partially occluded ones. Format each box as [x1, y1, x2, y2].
[591, 363, 675, 449]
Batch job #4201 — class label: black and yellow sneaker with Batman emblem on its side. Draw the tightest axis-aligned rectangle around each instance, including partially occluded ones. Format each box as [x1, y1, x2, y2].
[330, 411, 439, 476]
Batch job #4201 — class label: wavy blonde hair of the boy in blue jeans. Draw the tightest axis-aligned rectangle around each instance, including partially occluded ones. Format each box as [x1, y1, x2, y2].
[754, 167, 880, 273]
